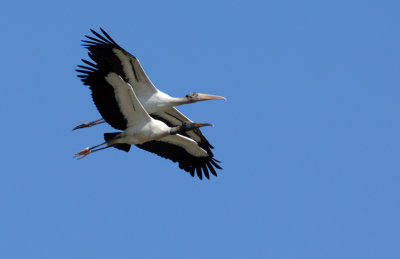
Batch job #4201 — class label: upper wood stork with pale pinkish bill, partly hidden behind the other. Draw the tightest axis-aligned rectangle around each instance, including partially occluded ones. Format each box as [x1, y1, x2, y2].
[74, 28, 226, 134]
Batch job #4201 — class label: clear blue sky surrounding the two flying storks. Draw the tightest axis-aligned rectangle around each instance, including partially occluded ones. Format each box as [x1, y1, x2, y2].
[0, 0, 400, 259]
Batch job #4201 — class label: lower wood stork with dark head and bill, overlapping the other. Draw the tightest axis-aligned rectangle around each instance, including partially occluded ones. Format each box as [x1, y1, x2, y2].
[74, 61, 222, 179]
